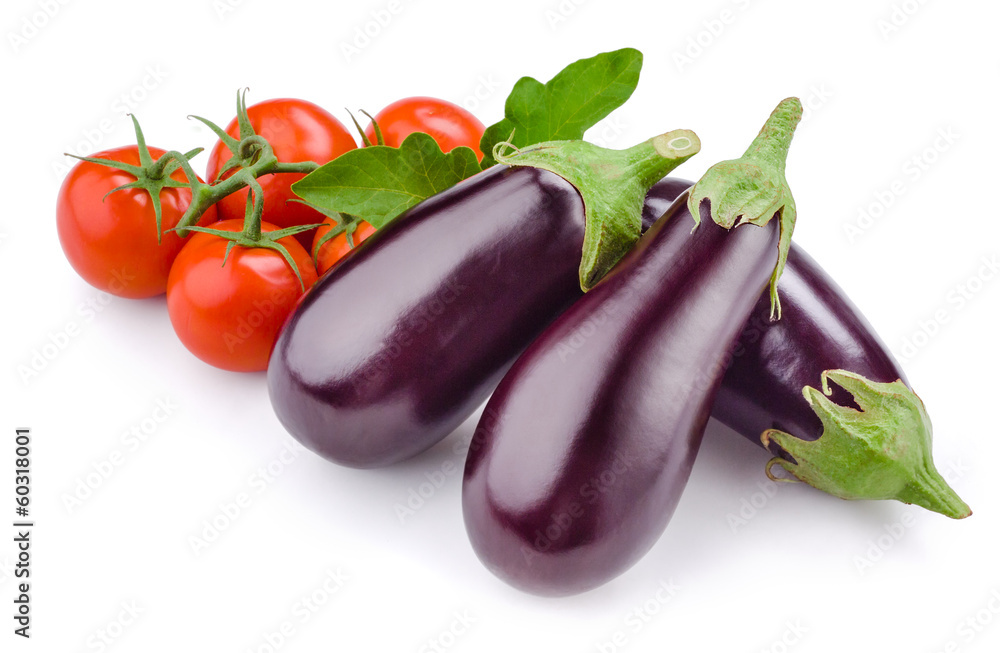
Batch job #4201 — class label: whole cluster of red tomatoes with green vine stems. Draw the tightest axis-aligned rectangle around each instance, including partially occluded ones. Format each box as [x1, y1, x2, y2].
[56, 97, 484, 371]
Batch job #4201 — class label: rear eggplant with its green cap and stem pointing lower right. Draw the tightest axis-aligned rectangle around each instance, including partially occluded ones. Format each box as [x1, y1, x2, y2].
[643, 178, 972, 519]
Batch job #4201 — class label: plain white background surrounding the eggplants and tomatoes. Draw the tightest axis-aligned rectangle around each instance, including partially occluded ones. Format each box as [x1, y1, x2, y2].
[0, 0, 1000, 653]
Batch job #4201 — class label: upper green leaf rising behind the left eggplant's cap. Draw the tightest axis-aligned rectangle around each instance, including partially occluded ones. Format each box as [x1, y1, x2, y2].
[479, 48, 642, 169]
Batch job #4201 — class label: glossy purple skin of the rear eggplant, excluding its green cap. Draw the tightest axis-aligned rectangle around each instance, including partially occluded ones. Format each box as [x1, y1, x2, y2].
[643, 178, 906, 457]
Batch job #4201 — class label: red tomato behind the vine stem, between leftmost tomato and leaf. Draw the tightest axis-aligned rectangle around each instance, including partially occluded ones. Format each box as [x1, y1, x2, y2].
[208, 99, 357, 247]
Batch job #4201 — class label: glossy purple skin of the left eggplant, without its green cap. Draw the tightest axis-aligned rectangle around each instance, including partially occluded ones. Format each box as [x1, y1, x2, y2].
[267, 166, 584, 467]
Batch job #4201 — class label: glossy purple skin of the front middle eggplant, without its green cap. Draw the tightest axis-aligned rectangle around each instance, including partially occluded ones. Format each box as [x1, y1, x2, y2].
[462, 196, 778, 595]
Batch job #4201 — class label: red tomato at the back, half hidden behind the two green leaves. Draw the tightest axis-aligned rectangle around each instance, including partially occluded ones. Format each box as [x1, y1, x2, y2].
[365, 97, 486, 159]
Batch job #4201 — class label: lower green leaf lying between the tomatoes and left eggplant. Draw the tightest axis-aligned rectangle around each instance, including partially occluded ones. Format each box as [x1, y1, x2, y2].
[292, 132, 480, 229]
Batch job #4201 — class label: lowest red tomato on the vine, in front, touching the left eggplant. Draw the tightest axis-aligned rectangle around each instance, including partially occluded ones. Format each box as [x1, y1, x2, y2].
[167, 219, 316, 372]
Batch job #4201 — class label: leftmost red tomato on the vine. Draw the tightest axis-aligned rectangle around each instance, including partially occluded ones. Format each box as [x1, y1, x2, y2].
[56, 145, 216, 299]
